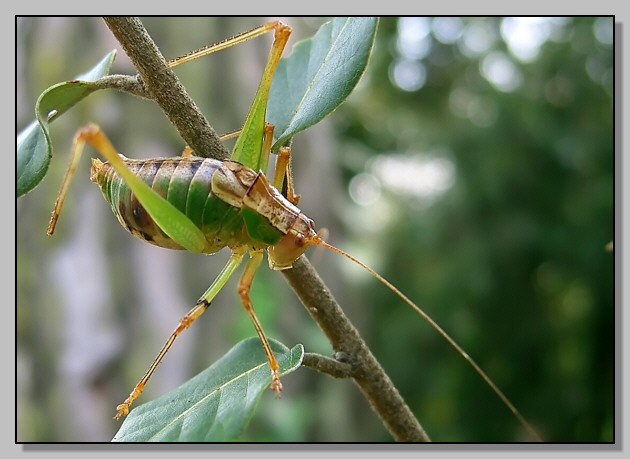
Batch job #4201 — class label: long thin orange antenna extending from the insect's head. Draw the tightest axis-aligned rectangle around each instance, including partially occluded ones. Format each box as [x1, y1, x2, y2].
[316, 237, 542, 442]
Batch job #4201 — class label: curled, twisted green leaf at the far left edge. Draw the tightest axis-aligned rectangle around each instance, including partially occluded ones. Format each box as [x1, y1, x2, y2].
[16, 50, 116, 197]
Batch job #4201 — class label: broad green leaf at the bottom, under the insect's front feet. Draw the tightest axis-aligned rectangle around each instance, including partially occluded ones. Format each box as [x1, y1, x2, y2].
[112, 337, 304, 442]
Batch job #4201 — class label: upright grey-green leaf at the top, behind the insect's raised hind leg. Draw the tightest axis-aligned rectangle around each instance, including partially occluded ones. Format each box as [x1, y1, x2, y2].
[267, 17, 378, 150]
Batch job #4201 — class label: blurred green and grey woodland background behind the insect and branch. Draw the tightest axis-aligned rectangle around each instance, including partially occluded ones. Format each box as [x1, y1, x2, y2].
[16, 17, 615, 443]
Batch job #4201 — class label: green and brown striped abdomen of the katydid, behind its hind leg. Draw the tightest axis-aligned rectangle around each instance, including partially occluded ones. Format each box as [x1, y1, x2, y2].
[91, 156, 250, 253]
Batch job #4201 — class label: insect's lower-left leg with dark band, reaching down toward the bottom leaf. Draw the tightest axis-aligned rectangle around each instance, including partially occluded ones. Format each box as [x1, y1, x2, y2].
[114, 248, 245, 420]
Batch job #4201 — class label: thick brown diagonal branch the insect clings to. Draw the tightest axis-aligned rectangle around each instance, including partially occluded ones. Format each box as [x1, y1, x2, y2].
[104, 17, 430, 442]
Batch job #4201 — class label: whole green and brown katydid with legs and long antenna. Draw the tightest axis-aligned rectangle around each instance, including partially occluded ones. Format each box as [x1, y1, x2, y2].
[48, 18, 537, 437]
